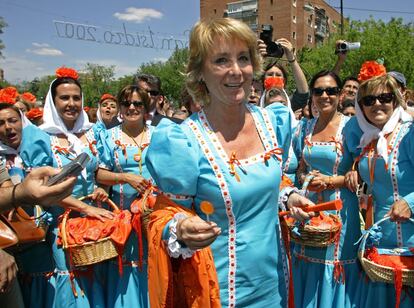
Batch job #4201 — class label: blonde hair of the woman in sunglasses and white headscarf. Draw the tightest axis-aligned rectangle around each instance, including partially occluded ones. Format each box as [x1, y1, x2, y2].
[357, 74, 407, 110]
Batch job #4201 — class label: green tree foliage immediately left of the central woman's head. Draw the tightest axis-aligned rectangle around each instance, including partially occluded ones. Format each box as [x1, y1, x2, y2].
[137, 48, 188, 105]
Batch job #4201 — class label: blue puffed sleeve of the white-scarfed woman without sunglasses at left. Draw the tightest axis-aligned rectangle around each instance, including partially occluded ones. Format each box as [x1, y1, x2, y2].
[20, 125, 53, 169]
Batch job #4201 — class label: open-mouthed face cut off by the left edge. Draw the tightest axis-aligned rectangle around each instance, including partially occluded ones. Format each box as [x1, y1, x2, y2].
[0, 108, 22, 149]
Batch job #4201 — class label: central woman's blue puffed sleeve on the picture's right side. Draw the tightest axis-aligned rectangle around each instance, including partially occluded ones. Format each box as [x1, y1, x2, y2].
[266, 104, 292, 165]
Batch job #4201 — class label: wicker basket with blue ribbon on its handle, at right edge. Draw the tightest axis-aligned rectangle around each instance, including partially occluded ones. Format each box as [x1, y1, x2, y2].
[358, 217, 414, 287]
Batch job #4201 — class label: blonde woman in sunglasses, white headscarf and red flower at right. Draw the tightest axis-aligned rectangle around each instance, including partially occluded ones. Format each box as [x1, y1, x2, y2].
[345, 61, 414, 308]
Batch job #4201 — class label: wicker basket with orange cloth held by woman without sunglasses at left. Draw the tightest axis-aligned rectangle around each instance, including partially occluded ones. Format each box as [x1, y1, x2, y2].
[61, 195, 119, 267]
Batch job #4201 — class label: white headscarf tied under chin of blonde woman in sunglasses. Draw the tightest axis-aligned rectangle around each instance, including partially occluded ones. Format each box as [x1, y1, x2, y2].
[355, 103, 412, 163]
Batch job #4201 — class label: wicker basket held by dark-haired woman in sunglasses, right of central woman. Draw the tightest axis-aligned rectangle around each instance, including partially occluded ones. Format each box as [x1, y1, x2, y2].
[285, 214, 342, 247]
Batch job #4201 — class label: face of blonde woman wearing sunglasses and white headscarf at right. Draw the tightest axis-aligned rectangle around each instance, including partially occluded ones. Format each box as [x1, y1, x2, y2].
[361, 87, 395, 129]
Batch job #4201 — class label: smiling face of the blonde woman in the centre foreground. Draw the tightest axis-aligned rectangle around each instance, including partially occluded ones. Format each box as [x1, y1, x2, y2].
[201, 36, 253, 106]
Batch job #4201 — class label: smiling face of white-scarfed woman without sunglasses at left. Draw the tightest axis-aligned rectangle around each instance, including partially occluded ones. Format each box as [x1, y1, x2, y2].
[54, 83, 82, 129]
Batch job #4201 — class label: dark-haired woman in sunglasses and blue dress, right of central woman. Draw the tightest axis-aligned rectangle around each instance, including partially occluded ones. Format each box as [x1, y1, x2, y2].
[292, 71, 360, 307]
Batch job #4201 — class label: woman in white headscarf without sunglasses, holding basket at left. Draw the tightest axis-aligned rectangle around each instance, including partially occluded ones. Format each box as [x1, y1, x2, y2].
[21, 68, 114, 307]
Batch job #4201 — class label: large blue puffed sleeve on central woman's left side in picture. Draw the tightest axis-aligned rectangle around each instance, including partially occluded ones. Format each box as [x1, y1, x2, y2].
[146, 119, 201, 206]
